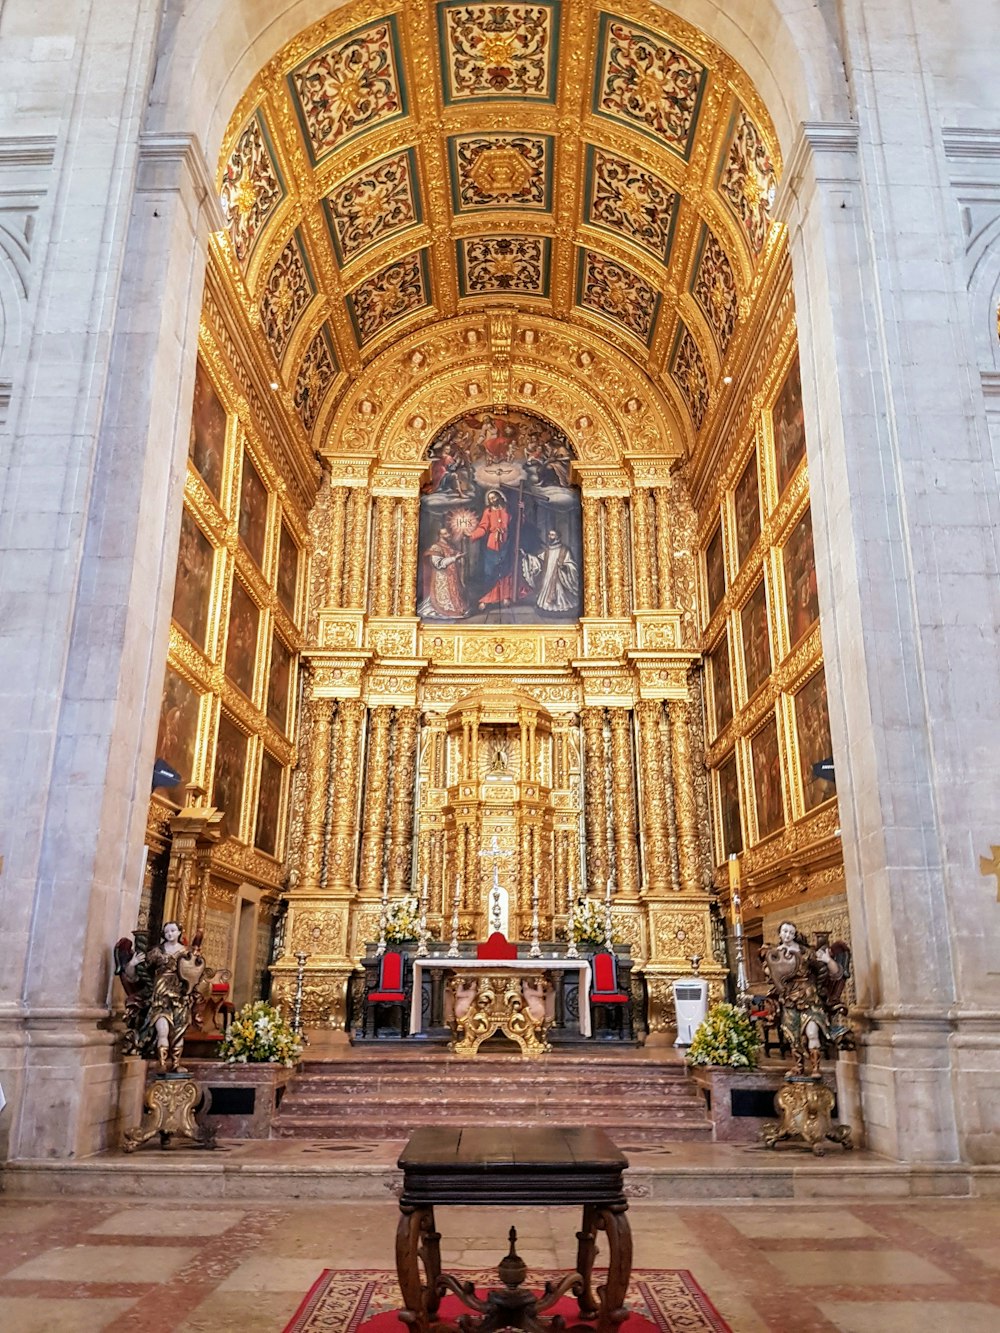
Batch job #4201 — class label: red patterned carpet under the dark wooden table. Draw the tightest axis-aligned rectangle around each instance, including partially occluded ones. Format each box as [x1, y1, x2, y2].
[284, 1268, 732, 1333]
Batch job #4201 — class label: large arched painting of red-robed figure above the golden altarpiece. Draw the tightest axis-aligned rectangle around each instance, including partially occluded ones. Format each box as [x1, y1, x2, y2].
[419, 412, 583, 625]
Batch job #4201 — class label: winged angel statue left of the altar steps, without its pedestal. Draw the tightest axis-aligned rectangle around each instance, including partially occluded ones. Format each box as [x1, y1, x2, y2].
[115, 921, 205, 1073]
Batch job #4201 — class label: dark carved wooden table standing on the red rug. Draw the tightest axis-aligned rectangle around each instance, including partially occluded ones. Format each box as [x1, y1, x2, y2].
[396, 1128, 632, 1333]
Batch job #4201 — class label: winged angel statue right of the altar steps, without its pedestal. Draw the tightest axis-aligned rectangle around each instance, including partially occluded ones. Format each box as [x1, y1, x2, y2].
[760, 921, 853, 1078]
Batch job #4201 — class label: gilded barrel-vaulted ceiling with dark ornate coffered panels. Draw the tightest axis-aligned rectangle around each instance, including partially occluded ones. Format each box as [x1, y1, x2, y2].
[217, 0, 780, 444]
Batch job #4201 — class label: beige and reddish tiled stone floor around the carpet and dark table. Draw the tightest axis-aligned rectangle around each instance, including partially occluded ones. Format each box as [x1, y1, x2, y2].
[0, 1200, 1000, 1333]
